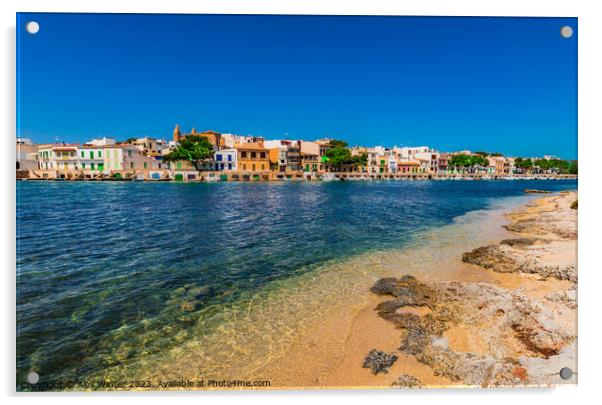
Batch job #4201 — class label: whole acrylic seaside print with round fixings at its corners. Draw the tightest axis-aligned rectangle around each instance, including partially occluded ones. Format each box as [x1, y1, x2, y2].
[16, 13, 578, 391]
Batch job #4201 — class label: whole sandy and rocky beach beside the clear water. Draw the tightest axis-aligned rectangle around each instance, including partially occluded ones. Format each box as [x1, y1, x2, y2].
[260, 191, 577, 388]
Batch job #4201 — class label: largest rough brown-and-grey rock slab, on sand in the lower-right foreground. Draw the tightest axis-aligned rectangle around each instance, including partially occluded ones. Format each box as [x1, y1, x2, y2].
[372, 275, 574, 386]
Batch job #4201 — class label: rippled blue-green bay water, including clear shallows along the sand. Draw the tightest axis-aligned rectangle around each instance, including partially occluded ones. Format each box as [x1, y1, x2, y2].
[17, 181, 576, 381]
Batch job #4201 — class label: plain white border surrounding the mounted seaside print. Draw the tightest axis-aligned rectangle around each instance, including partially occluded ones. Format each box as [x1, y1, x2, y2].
[0, 0, 602, 404]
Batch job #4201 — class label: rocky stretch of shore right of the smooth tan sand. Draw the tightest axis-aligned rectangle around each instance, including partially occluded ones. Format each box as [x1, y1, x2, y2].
[364, 192, 577, 387]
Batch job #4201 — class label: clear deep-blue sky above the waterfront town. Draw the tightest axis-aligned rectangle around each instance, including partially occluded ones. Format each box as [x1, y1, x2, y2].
[17, 13, 577, 158]
